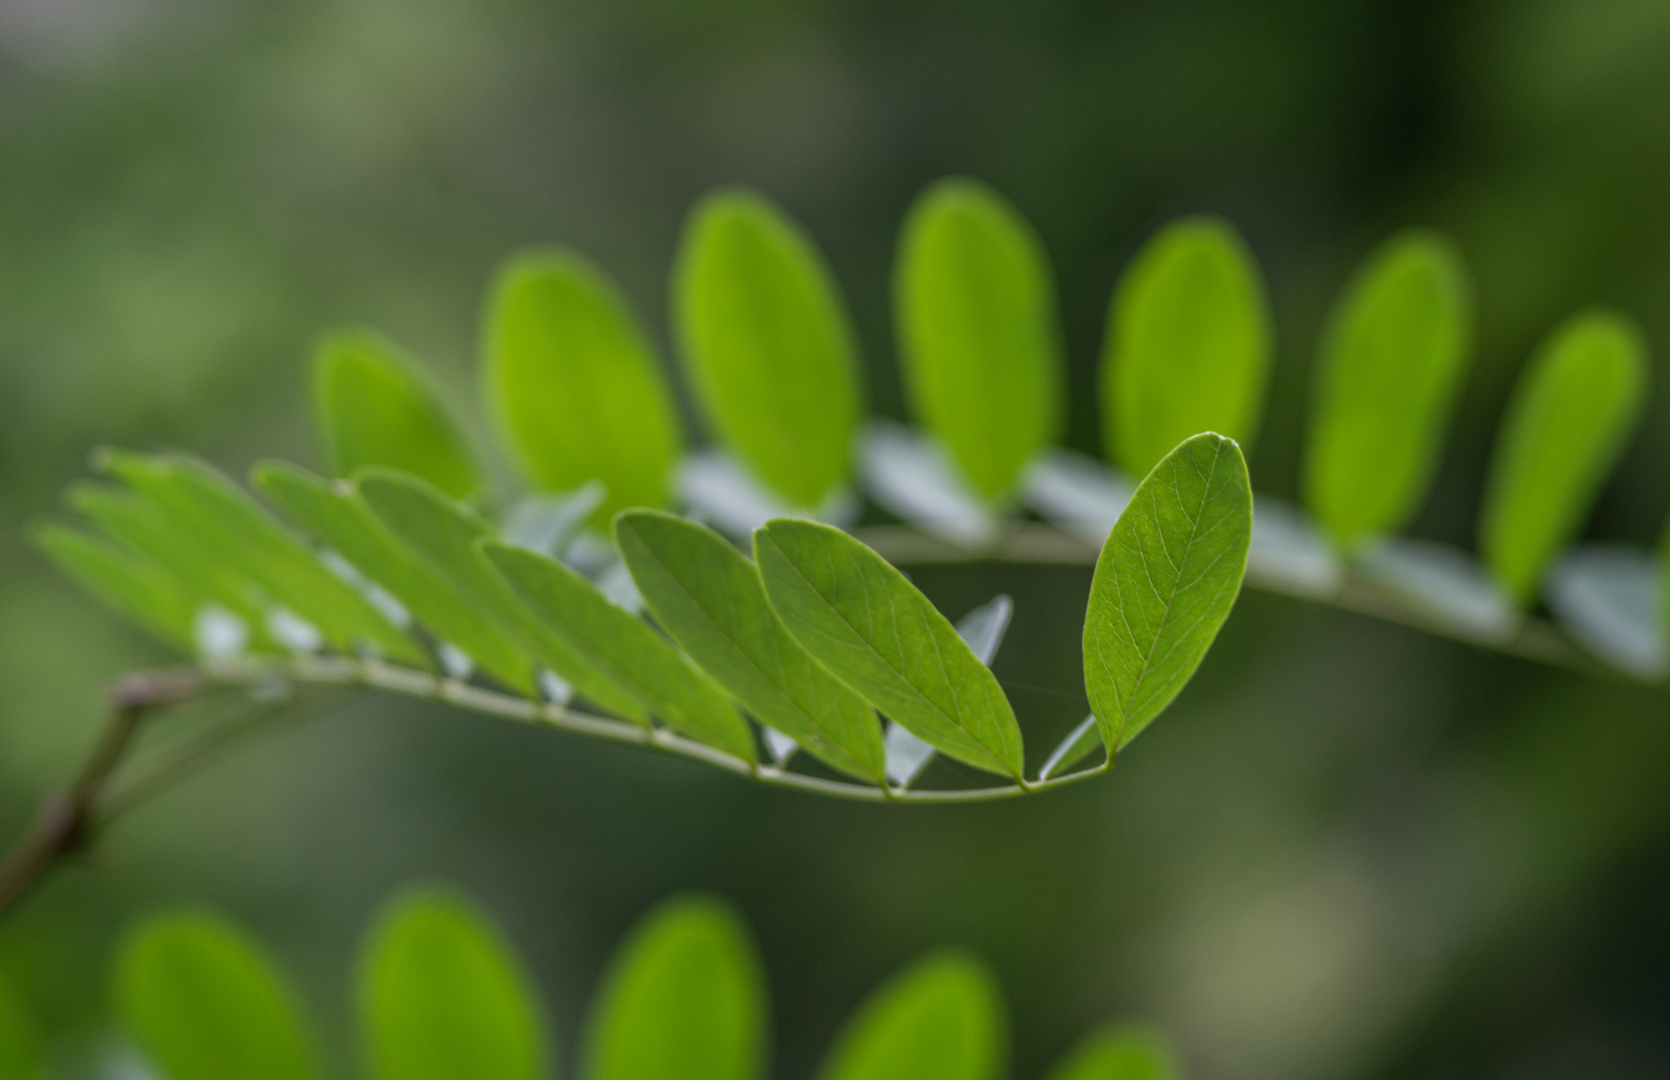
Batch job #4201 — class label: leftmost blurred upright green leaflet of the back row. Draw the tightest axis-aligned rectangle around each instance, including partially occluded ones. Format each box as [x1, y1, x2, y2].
[312, 331, 481, 499]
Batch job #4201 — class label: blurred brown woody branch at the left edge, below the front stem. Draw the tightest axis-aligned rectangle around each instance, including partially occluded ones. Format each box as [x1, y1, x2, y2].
[0, 671, 202, 918]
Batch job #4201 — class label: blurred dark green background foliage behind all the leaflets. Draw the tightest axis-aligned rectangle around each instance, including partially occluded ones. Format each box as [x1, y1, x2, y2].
[0, 0, 1670, 1080]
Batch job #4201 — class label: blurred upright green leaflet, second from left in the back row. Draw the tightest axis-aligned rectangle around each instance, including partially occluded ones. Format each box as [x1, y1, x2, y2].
[483, 249, 683, 527]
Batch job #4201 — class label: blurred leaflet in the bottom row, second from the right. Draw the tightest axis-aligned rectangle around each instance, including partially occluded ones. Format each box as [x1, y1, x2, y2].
[818, 953, 1007, 1080]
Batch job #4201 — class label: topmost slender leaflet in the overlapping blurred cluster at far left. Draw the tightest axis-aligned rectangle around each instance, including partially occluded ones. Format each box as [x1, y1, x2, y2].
[104, 452, 429, 668]
